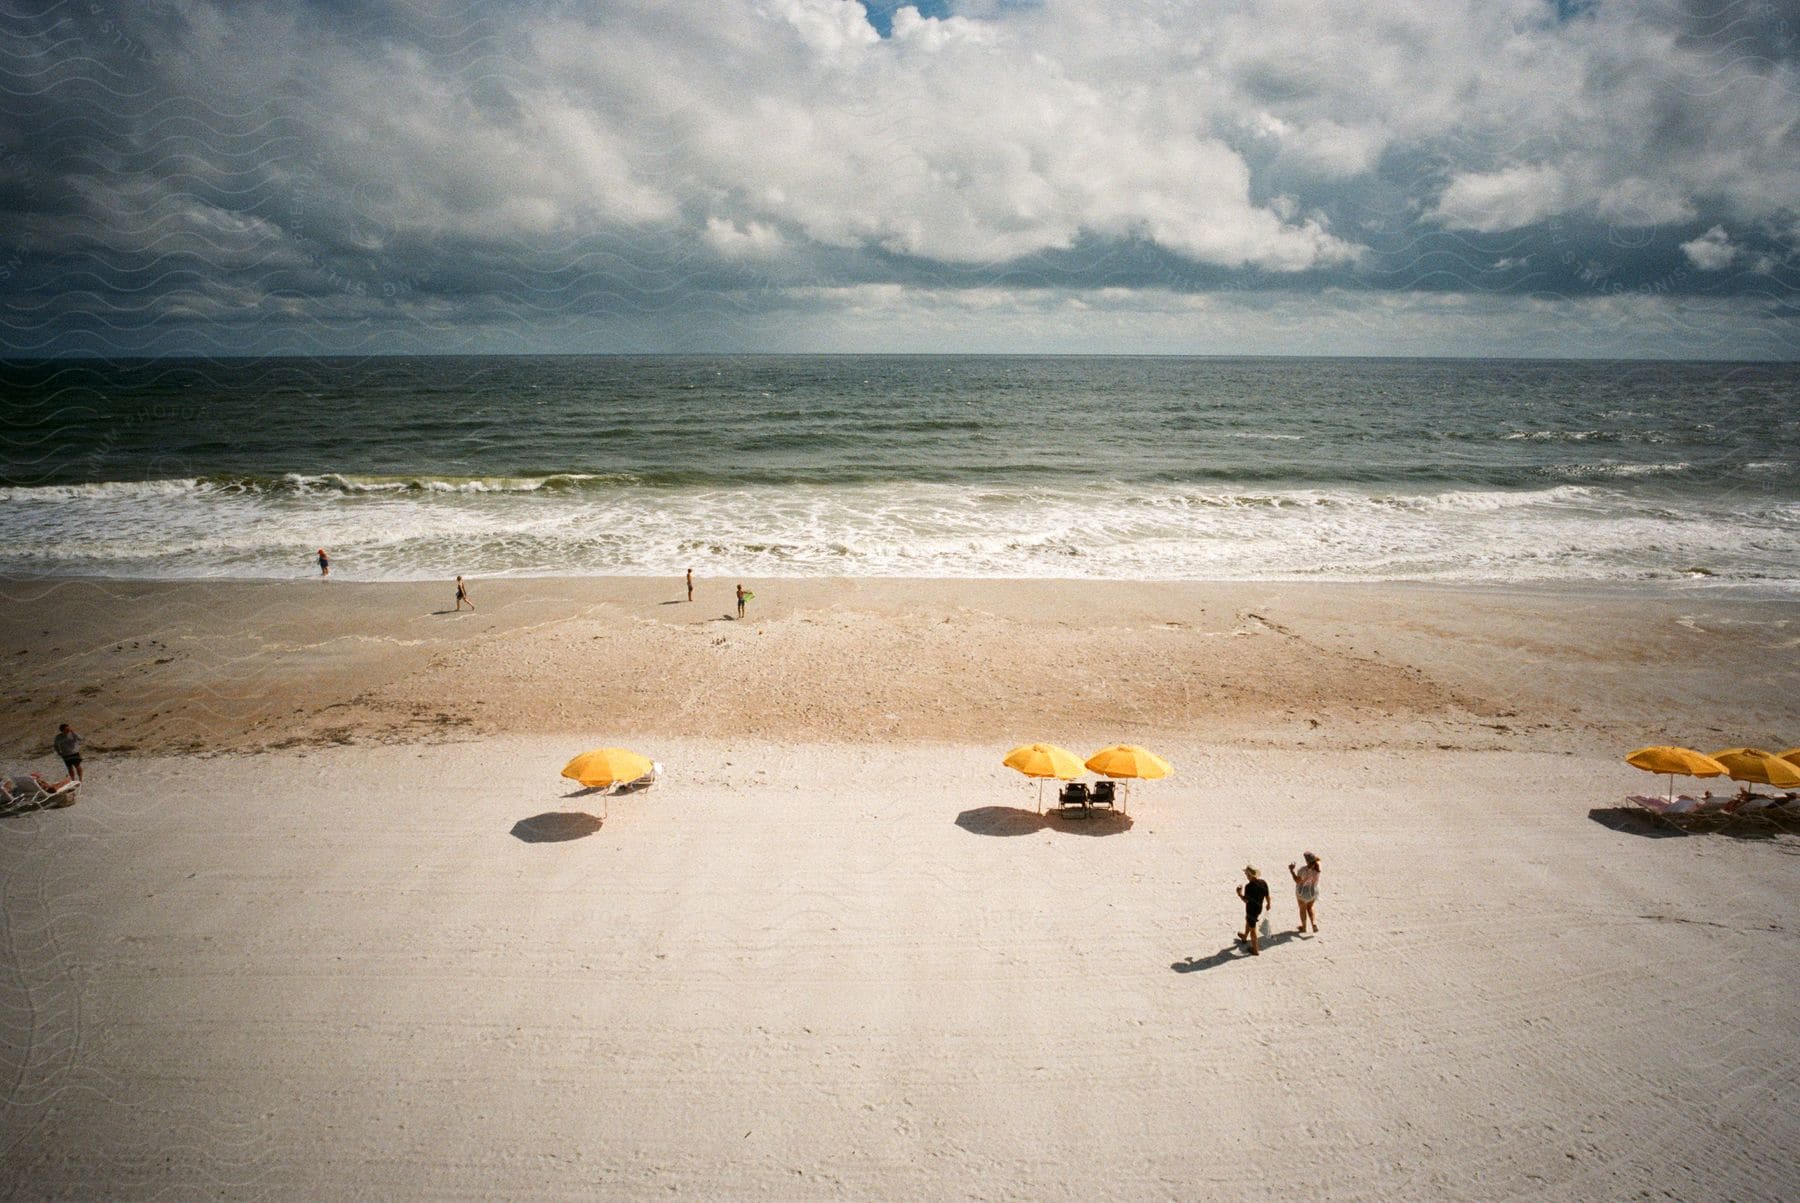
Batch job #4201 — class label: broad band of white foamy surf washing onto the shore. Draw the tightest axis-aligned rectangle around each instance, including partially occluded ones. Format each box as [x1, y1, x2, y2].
[0, 477, 1800, 582]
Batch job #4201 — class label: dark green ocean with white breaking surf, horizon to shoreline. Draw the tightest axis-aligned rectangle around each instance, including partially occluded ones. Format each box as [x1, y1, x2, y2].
[0, 355, 1800, 591]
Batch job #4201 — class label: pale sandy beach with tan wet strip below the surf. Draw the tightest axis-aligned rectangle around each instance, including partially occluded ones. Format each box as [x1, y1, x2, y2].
[0, 578, 1800, 1199]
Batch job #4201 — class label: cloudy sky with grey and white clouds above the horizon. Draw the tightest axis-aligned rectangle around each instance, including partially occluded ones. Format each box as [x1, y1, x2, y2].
[0, 0, 1800, 360]
